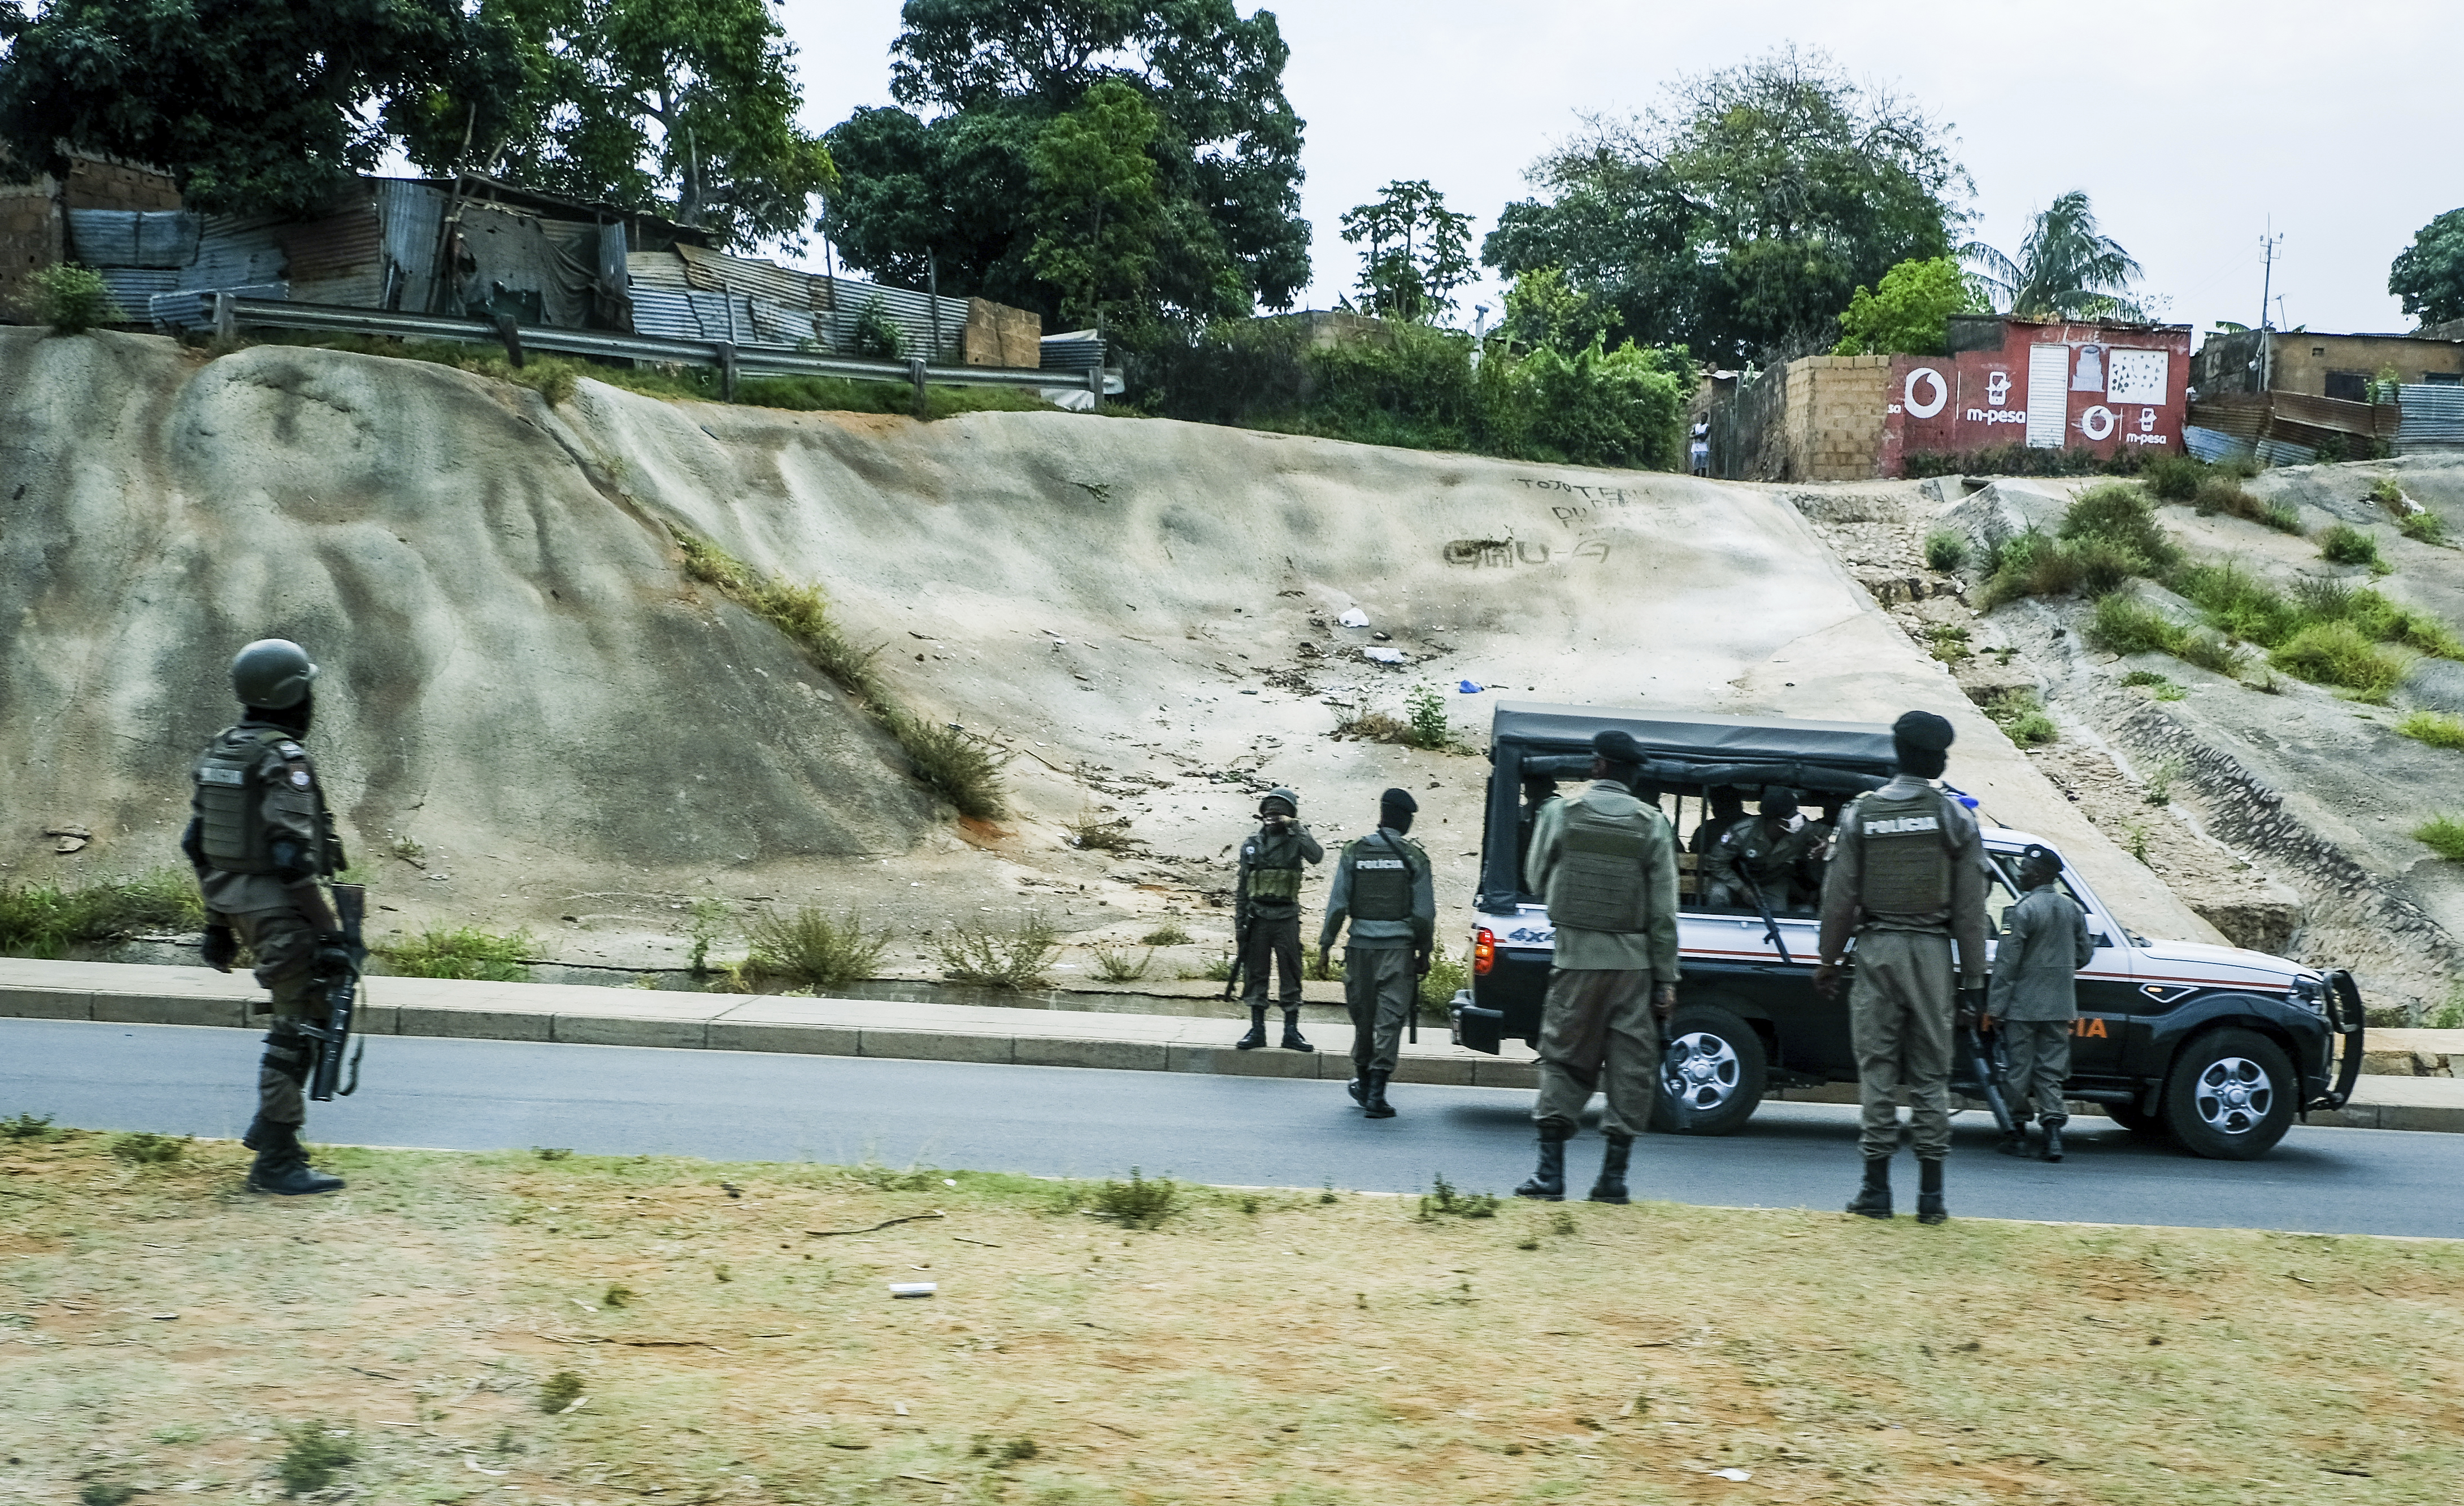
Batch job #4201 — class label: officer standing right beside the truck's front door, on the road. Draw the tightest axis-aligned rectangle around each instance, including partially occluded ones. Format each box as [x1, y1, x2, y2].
[1986, 843, 2097, 1161]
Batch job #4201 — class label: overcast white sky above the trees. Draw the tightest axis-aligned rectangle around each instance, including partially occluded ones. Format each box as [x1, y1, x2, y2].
[781, 0, 2464, 330]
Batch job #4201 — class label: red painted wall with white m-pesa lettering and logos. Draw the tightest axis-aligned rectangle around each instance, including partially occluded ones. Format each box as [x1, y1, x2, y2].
[1880, 318, 2191, 476]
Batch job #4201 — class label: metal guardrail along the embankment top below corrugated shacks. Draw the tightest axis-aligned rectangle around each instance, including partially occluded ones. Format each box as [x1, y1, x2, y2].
[207, 293, 1104, 414]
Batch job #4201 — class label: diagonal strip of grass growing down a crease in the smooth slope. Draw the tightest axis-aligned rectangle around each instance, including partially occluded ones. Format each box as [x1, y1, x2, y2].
[675, 530, 1008, 821]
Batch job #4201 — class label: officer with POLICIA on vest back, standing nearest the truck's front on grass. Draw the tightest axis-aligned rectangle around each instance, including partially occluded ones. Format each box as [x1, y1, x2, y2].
[1814, 713, 1986, 1222]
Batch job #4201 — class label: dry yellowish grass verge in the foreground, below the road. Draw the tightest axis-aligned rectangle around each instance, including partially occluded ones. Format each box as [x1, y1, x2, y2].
[0, 1139, 2464, 1506]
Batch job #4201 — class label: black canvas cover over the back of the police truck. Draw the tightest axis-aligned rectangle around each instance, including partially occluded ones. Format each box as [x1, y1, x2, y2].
[1474, 700, 1900, 909]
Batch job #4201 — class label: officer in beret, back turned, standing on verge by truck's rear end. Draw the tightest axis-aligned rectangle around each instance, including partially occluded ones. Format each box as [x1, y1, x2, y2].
[1515, 730, 1678, 1203]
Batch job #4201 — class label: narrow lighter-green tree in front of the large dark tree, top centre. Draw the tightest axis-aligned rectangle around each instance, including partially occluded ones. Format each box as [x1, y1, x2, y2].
[1028, 79, 1163, 325]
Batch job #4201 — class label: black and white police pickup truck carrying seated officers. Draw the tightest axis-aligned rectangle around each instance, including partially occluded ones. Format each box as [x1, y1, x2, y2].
[1452, 702, 2363, 1161]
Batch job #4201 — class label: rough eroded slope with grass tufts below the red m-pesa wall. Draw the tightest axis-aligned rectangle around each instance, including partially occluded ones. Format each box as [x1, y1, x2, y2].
[1794, 458, 2464, 1023]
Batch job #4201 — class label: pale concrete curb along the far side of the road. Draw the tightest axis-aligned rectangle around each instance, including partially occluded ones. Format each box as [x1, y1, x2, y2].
[0, 959, 2464, 1134]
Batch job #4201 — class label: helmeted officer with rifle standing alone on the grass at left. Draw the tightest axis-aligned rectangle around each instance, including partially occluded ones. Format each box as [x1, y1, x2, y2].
[180, 639, 350, 1195]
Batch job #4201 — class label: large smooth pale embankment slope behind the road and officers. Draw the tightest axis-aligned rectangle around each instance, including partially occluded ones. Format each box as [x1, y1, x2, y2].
[0, 330, 2213, 969]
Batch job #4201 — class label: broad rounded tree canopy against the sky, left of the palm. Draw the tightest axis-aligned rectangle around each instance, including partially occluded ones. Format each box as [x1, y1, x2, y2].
[1481, 49, 1968, 365]
